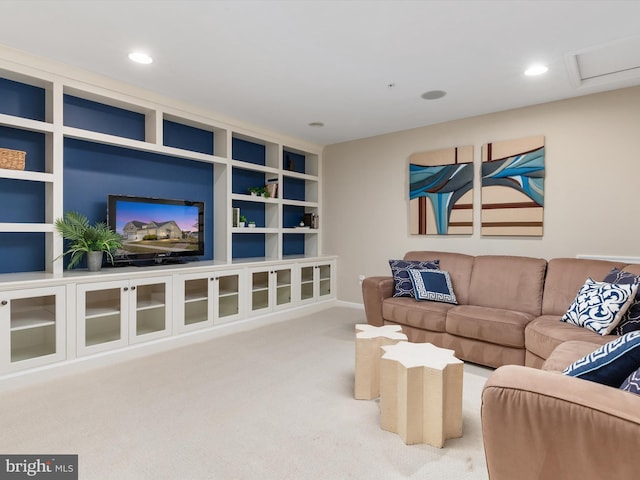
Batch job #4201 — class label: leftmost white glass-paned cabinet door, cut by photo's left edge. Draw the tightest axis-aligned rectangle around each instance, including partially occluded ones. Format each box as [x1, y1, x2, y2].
[0, 286, 66, 373]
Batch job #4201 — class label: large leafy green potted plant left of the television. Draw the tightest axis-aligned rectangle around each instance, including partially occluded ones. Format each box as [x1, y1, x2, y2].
[55, 212, 122, 272]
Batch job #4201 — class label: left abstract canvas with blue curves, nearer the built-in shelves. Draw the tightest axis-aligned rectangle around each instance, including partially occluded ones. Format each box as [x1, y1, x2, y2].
[409, 146, 473, 235]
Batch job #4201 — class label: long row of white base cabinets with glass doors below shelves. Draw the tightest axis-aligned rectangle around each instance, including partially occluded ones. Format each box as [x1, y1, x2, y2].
[0, 256, 336, 390]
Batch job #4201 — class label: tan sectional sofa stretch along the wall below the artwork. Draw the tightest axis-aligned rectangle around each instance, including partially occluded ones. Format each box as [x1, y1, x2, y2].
[362, 251, 640, 368]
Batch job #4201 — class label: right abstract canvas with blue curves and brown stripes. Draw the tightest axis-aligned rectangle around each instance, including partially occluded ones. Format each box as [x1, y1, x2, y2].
[481, 136, 545, 236]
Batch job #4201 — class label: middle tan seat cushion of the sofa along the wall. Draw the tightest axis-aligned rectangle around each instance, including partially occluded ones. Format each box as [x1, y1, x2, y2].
[446, 305, 534, 348]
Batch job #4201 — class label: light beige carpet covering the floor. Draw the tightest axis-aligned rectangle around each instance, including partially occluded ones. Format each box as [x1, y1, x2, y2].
[0, 307, 489, 480]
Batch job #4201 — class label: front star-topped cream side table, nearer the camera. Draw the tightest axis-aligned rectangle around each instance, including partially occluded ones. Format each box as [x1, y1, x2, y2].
[380, 342, 464, 448]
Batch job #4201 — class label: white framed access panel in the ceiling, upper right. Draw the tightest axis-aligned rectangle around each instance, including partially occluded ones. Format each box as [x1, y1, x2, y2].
[565, 37, 640, 87]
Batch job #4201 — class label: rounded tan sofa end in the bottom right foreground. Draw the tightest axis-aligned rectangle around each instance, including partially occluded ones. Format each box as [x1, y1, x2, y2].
[481, 365, 640, 480]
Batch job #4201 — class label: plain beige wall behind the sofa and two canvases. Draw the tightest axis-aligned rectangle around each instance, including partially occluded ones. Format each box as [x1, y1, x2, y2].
[321, 87, 640, 303]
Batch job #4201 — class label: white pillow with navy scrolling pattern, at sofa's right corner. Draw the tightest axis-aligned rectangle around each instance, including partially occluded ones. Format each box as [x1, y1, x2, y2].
[560, 278, 638, 335]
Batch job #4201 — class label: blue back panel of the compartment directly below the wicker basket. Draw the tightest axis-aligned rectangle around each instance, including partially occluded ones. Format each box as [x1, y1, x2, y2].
[0, 178, 47, 223]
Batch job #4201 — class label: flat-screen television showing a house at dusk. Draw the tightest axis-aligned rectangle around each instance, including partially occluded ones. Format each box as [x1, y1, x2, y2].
[107, 195, 204, 265]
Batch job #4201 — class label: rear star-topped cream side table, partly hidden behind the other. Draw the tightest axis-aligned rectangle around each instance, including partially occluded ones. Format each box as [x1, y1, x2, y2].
[354, 323, 407, 400]
